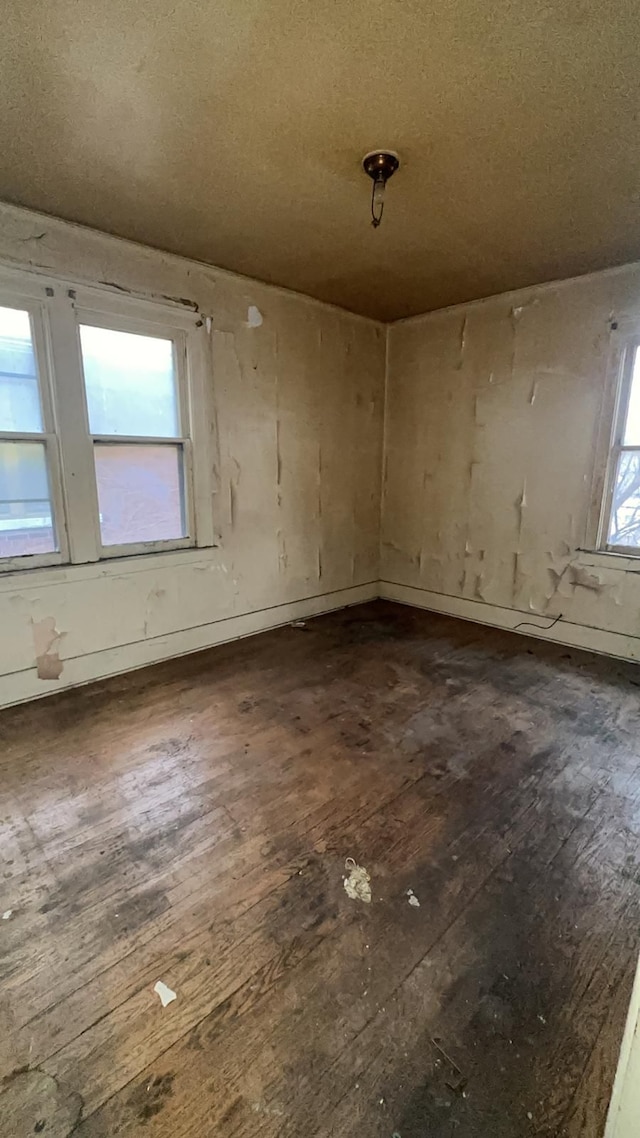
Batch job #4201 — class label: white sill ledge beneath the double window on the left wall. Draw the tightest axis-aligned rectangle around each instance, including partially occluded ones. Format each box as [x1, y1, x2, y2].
[0, 545, 219, 593]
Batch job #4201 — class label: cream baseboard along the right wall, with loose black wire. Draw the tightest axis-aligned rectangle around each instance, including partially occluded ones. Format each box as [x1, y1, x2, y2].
[379, 580, 640, 660]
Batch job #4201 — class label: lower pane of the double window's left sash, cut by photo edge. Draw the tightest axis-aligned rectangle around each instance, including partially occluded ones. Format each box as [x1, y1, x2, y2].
[0, 442, 57, 558]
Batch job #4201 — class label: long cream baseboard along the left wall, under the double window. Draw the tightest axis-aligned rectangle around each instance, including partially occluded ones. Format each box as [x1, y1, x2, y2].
[0, 582, 378, 707]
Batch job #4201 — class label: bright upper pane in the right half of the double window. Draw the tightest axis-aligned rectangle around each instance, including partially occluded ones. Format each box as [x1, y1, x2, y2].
[80, 324, 180, 438]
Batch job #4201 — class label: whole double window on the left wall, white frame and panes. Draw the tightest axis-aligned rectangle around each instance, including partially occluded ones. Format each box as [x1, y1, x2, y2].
[0, 270, 213, 570]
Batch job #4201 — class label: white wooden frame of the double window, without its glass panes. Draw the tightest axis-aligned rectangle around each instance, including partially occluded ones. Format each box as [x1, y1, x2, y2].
[0, 266, 215, 574]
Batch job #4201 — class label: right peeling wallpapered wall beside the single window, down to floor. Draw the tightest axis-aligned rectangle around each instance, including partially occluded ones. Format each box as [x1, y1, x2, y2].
[380, 265, 640, 657]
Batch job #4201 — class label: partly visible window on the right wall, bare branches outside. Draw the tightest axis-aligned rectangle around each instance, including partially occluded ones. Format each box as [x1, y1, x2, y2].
[601, 338, 640, 556]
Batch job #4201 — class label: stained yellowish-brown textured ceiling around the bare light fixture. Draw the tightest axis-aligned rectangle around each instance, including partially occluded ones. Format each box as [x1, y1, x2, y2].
[0, 0, 640, 320]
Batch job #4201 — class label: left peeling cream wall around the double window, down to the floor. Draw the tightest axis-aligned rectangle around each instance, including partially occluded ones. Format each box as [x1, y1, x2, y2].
[0, 205, 385, 703]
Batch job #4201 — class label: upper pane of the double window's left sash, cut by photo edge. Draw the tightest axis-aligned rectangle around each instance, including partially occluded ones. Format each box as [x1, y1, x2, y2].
[0, 307, 42, 431]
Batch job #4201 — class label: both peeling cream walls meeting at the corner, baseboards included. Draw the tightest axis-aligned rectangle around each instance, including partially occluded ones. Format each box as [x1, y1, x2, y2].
[0, 205, 640, 703]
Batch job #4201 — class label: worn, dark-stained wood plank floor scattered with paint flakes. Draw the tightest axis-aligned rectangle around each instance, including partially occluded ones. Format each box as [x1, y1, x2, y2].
[0, 602, 640, 1138]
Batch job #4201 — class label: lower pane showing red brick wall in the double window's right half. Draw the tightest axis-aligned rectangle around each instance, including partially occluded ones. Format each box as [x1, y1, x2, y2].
[93, 443, 187, 545]
